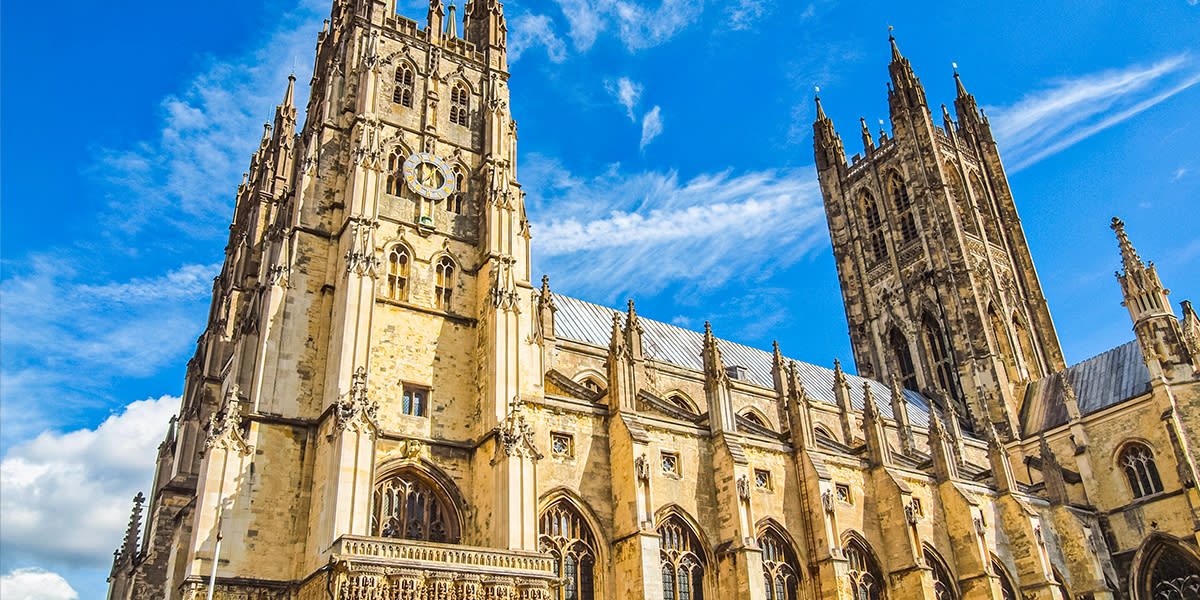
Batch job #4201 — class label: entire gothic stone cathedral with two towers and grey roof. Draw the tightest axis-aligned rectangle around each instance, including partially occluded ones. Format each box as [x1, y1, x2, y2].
[109, 0, 1200, 600]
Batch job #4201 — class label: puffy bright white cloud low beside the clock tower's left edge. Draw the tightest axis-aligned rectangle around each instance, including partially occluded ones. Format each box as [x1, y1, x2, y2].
[0, 396, 180, 568]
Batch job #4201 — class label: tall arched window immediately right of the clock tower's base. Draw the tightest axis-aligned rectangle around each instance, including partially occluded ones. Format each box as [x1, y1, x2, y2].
[538, 500, 596, 600]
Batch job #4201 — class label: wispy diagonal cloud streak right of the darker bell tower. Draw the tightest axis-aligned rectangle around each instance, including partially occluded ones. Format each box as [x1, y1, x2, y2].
[986, 54, 1200, 172]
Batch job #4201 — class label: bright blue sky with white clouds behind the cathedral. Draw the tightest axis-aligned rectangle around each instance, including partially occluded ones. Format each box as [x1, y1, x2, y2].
[0, 0, 1200, 599]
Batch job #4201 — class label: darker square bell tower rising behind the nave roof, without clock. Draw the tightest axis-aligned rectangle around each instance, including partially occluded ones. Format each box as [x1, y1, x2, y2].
[812, 37, 1064, 436]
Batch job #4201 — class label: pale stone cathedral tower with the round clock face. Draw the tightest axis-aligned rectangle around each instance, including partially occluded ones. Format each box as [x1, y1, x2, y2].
[106, 0, 551, 598]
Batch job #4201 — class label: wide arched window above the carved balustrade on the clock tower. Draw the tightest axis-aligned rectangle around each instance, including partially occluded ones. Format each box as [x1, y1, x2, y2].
[371, 468, 458, 544]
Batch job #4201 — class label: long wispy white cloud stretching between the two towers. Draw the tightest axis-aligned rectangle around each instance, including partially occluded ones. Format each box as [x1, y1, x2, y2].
[522, 155, 826, 300]
